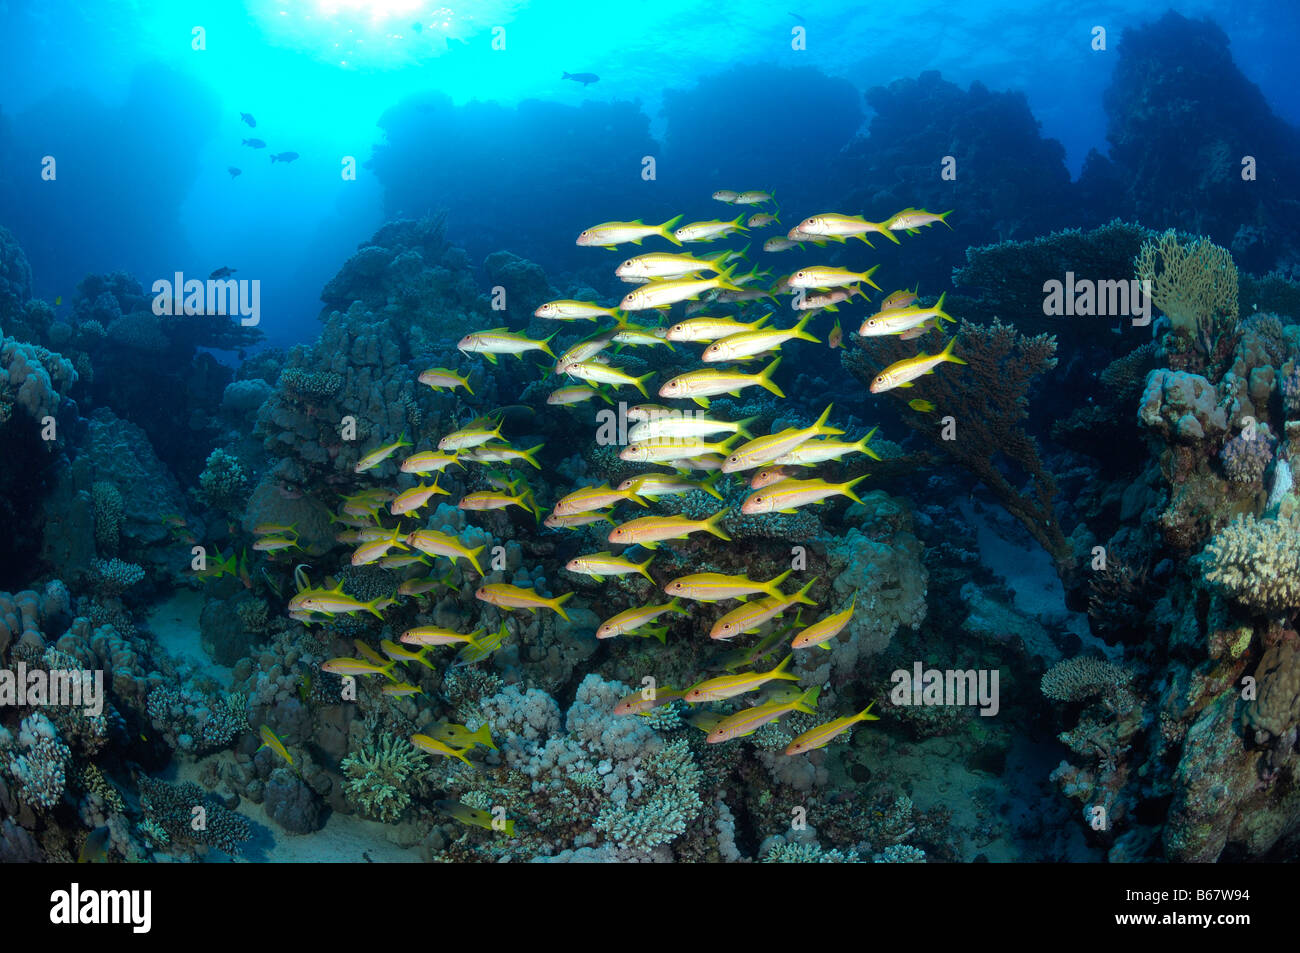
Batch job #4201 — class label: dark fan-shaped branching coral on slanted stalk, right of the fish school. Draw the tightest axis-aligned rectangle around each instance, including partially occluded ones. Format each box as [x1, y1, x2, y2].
[844, 321, 1074, 575]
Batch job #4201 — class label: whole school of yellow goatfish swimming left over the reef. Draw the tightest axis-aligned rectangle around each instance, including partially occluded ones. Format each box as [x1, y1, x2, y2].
[254, 190, 965, 833]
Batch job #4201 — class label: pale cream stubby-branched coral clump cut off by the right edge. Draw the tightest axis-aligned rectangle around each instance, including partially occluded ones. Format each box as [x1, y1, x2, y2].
[1203, 512, 1300, 612]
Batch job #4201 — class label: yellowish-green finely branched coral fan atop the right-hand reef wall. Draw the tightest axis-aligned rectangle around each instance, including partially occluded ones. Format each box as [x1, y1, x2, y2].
[1134, 229, 1238, 355]
